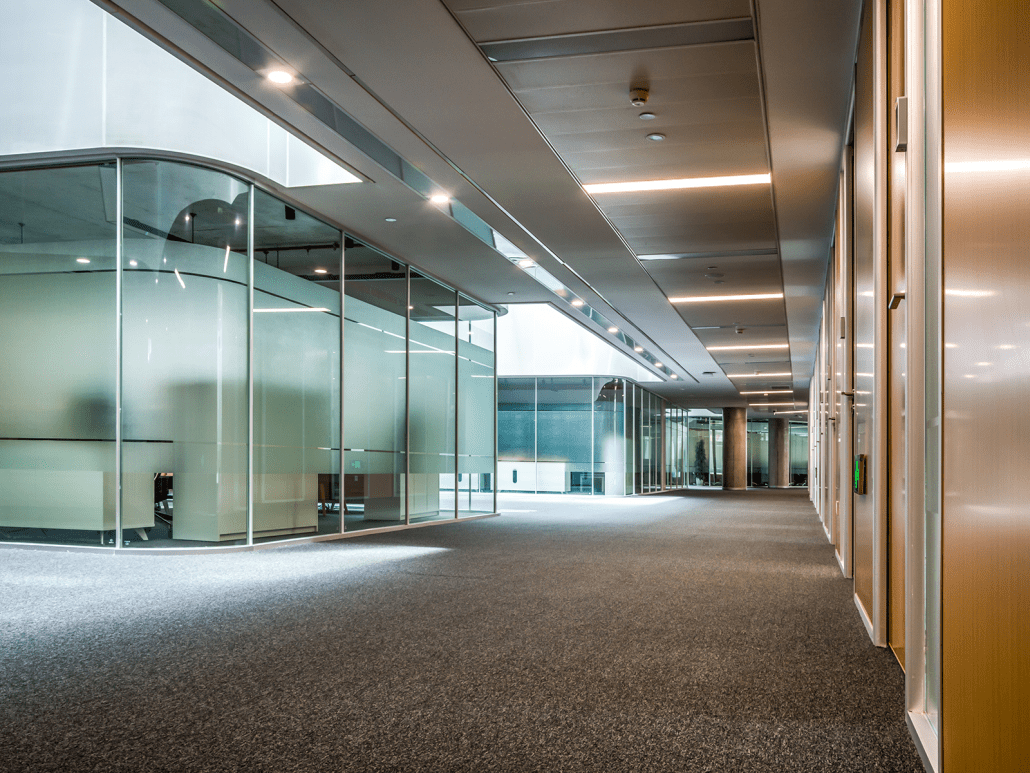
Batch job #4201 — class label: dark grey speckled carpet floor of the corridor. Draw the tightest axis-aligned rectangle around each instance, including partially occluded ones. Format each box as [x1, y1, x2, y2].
[0, 491, 922, 773]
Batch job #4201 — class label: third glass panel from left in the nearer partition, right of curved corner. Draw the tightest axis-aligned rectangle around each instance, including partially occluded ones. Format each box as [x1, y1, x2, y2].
[252, 190, 343, 541]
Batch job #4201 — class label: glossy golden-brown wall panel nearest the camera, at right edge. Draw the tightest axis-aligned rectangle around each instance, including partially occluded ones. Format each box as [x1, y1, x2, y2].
[940, 0, 1030, 773]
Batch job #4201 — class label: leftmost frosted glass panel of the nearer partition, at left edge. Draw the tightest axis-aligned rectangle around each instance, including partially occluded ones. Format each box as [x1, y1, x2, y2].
[0, 163, 116, 545]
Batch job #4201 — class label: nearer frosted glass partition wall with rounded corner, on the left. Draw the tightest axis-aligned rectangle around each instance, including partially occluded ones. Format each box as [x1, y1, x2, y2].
[0, 159, 496, 548]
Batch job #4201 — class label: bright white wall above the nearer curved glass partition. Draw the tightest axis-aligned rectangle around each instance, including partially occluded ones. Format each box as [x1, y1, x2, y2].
[0, 0, 359, 187]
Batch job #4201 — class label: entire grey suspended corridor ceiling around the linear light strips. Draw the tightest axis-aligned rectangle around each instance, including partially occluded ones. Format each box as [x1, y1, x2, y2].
[94, 0, 860, 415]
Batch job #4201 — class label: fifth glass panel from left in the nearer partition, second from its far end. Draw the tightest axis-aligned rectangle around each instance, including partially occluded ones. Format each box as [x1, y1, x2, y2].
[407, 271, 457, 523]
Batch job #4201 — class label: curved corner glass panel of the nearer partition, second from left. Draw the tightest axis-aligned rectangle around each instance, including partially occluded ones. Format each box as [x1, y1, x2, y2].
[122, 161, 250, 547]
